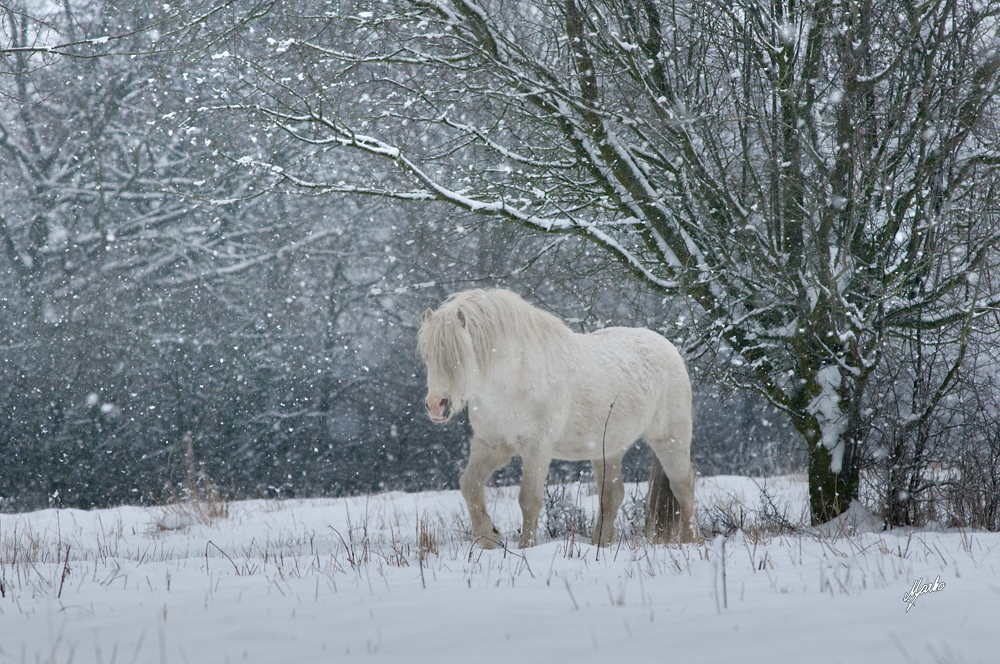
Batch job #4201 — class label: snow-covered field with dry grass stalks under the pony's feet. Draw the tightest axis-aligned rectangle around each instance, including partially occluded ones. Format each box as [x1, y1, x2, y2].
[0, 477, 1000, 664]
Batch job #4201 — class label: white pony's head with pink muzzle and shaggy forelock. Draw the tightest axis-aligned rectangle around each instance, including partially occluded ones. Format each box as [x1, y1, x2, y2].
[417, 301, 479, 424]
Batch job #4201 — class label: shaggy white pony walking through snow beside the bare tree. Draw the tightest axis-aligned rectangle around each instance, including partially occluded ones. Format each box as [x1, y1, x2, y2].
[417, 290, 701, 549]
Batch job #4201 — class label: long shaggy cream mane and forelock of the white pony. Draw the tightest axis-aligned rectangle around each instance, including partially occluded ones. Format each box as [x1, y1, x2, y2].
[417, 289, 572, 393]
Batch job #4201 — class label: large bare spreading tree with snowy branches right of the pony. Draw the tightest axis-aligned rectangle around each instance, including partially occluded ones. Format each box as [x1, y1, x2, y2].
[199, 0, 1000, 522]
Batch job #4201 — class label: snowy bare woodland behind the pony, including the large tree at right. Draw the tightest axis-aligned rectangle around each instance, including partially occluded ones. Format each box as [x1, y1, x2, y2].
[0, 0, 1000, 529]
